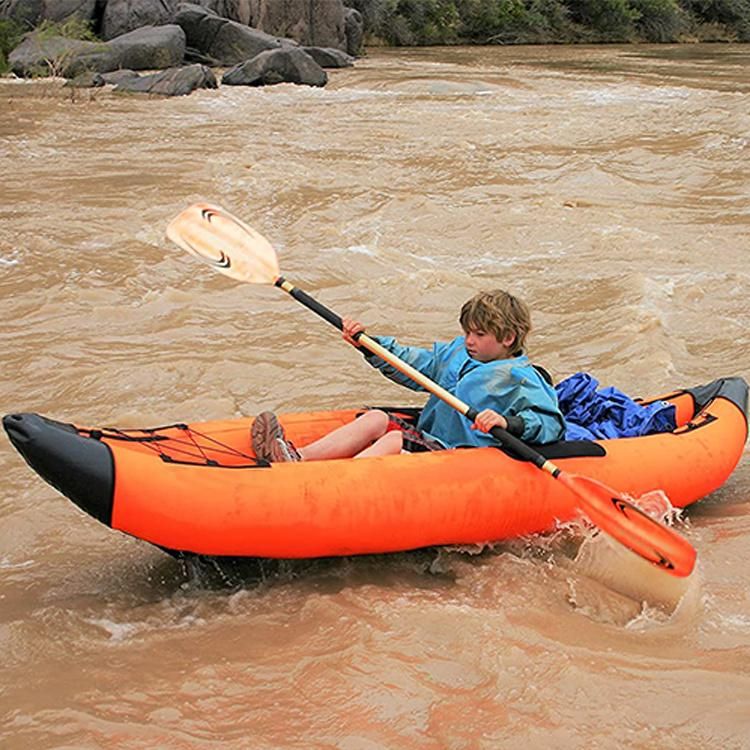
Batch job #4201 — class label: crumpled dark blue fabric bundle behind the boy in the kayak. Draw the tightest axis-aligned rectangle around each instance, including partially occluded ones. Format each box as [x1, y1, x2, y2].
[555, 372, 676, 440]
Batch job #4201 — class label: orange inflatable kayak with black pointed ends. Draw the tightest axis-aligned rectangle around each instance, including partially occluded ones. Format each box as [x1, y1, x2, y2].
[3, 378, 748, 558]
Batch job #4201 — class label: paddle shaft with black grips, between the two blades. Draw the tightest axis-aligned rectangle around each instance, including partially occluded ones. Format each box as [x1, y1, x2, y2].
[274, 276, 559, 477]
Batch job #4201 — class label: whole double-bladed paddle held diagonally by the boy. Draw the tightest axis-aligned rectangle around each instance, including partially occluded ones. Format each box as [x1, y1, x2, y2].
[167, 203, 696, 577]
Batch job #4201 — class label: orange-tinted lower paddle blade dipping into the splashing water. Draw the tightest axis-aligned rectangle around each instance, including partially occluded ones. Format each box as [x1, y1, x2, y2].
[557, 472, 696, 578]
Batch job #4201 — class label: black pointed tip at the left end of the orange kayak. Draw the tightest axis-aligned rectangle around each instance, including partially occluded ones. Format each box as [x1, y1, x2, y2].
[3, 414, 115, 527]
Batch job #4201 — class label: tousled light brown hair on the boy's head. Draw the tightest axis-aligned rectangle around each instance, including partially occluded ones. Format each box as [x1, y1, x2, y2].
[458, 289, 531, 355]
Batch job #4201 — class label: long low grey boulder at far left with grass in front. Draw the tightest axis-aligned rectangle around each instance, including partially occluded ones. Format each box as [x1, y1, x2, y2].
[8, 25, 185, 78]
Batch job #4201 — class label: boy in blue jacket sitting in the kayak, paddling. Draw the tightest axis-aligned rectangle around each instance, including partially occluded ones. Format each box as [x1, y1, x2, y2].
[252, 290, 565, 461]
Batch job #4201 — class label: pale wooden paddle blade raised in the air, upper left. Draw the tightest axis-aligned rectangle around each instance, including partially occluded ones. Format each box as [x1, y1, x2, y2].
[167, 203, 280, 284]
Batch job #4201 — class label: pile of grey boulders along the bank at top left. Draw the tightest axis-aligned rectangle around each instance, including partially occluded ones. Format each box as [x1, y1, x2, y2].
[0, 0, 363, 96]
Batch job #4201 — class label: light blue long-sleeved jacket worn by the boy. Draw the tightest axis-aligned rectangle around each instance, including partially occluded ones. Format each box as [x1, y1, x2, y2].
[365, 336, 565, 448]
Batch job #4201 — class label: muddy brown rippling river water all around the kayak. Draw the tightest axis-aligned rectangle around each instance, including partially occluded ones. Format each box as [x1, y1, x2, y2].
[0, 46, 750, 750]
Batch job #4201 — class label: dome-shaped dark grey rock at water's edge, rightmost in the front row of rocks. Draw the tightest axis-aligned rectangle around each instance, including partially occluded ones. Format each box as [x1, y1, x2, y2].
[221, 47, 328, 86]
